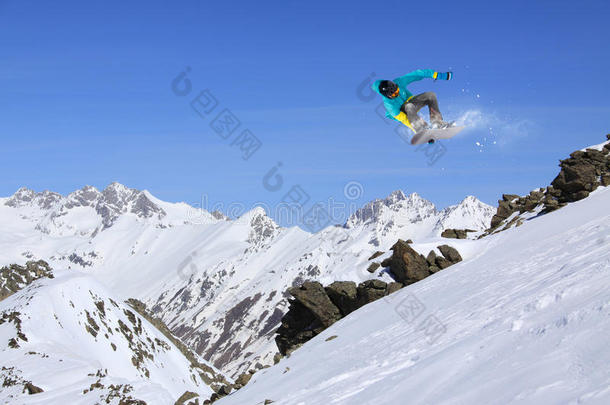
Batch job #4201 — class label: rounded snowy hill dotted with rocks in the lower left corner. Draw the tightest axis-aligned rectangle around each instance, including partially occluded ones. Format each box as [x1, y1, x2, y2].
[0, 271, 217, 404]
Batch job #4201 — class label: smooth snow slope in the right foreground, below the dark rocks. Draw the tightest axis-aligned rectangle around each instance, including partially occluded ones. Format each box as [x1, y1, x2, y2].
[217, 187, 610, 405]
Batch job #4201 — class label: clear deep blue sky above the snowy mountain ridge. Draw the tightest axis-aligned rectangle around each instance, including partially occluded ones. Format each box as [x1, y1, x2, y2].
[0, 0, 610, 227]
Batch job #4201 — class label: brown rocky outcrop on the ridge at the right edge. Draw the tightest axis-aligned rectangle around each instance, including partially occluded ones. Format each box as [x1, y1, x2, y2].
[481, 134, 610, 237]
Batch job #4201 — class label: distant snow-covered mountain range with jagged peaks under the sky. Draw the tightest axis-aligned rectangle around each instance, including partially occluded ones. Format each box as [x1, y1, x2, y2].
[0, 183, 494, 376]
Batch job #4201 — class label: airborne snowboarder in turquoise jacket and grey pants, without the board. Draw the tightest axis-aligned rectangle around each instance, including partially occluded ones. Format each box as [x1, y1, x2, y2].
[372, 69, 453, 133]
